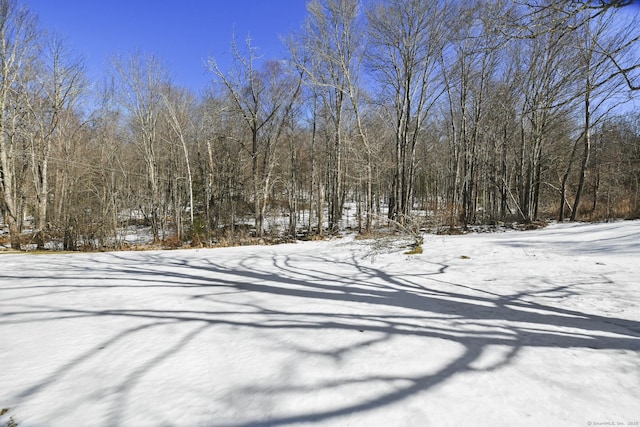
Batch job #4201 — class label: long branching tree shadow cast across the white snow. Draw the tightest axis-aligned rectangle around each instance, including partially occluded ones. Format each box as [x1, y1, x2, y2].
[0, 242, 640, 427]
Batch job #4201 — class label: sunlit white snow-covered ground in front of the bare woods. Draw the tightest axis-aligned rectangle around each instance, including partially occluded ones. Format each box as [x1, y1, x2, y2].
[0, 221, 640, 427]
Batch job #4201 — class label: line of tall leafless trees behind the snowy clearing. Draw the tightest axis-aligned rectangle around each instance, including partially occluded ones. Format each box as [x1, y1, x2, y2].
[0, 0, 640, 250]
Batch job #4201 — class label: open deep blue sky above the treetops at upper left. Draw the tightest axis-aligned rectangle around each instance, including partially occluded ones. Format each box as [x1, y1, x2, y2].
[24, 0, 306, 91]
